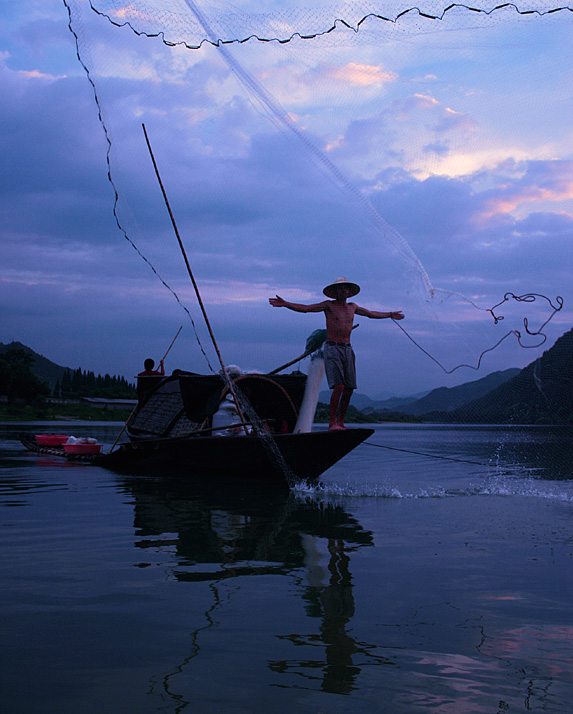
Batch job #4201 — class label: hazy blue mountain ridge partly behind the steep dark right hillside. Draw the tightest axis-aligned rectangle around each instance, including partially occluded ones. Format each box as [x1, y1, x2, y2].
[394, 368, 520, 416]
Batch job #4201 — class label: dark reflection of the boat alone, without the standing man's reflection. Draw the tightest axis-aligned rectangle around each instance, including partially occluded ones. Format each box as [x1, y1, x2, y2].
[122, 477, 373, 581]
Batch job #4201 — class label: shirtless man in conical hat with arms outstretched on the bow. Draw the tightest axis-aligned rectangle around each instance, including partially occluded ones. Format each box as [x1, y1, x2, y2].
[269, 278, 404, 431]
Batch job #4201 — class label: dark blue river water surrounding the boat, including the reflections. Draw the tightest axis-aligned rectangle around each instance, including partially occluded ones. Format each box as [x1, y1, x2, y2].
[0, 422, 573, 714]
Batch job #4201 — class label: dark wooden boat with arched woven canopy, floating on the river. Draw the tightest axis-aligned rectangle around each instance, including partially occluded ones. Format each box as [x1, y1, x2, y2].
[20, 371, 373, 483]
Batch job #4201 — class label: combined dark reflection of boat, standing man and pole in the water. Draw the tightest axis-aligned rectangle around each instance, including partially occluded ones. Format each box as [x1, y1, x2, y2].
[123, 478, 380, 700]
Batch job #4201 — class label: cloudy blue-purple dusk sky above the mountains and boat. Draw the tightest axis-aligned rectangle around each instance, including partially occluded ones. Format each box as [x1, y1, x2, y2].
[0, 0, 573, 396]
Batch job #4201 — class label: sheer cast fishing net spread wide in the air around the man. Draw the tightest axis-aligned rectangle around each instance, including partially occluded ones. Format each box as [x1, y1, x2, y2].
[65, 0, 573, 432]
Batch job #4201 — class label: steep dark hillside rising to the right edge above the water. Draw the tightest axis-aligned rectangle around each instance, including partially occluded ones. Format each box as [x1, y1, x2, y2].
[424, 330, 573, 424]
